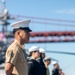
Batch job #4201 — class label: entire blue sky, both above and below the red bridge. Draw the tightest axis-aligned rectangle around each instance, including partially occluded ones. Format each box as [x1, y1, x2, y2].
[0, 0, 75, 75]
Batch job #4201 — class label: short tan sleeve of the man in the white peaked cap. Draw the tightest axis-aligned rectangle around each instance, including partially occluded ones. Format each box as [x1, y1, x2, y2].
[6, 50, 18, 65]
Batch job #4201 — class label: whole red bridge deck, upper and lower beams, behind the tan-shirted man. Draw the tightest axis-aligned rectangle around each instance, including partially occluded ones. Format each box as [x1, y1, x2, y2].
[4, 31, 75, 43]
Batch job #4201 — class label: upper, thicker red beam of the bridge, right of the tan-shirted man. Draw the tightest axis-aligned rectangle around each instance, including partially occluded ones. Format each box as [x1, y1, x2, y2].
[30, 31, 75, 37]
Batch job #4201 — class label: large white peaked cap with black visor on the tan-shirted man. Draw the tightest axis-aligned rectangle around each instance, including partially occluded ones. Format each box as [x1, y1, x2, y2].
[10, 20, 31, 31]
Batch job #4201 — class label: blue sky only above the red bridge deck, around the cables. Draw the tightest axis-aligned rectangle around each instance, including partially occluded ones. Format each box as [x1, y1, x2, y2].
[6, 0, 75, 31]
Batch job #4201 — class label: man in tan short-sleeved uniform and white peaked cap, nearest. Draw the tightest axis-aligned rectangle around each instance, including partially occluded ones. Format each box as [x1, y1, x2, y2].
[5, 20, 31, 75]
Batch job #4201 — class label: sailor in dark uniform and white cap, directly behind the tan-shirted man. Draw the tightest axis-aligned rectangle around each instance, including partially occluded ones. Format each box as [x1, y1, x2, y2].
[28, 46, 42, 75]
